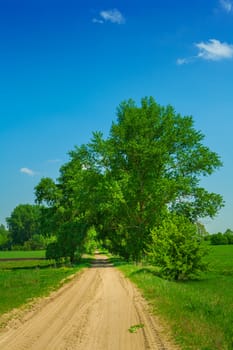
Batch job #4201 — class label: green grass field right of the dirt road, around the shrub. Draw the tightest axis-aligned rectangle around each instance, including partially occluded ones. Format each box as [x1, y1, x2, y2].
[114, 245, 233, 350]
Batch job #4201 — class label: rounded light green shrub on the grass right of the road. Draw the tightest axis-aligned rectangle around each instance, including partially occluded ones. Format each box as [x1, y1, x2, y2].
[147, 215, 207, 280]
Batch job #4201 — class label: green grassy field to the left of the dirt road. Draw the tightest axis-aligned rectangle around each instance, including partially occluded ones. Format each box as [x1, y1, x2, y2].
[0, 252, 88, 315]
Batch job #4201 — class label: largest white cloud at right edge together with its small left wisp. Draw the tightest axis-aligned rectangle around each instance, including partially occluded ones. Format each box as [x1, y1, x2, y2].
[176, 39, 233, 65]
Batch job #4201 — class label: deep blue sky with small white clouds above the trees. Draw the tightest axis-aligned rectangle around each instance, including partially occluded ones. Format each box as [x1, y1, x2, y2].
[0, 0, 233, 232]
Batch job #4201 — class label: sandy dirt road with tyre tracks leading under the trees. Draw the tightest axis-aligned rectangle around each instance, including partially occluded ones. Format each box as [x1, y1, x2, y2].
[0, 255, 177, 350]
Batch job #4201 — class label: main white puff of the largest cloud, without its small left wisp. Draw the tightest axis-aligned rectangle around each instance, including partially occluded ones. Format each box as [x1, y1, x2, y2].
[195, 39, 233, 61]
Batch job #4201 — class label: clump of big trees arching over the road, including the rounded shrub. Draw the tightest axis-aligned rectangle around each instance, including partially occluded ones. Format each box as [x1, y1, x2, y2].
[31, 98, 223, 279]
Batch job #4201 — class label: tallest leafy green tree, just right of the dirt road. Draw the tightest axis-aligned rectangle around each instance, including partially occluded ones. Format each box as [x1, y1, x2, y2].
[88, 98, 223, 259]
